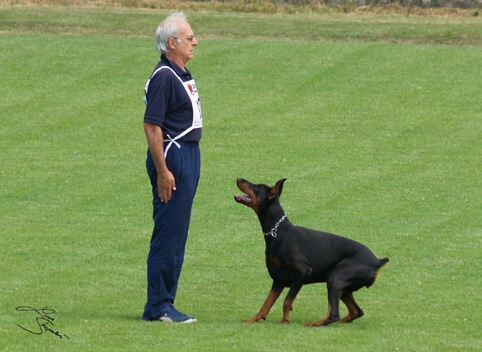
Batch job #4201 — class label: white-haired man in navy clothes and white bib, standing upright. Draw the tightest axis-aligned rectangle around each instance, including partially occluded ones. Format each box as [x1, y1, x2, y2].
[143, 13, 202, 323]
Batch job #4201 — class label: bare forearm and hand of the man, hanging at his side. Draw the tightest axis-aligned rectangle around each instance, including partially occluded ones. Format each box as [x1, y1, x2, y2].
[144, 122, 176, 203]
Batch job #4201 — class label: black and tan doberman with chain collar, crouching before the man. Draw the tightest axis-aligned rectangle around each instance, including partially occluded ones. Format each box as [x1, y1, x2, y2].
[234, 178, 388, 326]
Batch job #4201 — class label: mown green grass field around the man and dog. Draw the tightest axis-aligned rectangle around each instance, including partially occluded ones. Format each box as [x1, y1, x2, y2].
[0, 7, 482, 352]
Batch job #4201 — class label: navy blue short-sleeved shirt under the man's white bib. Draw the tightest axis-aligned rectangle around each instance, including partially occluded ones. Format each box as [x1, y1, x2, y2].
[144, 54, 202, 142]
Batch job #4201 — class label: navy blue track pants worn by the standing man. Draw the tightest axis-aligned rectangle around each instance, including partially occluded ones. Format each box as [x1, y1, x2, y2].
[143, 142, 201, 320]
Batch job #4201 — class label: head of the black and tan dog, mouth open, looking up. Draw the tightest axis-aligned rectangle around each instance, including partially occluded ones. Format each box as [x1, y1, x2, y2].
[234, 178, 286, 215]
